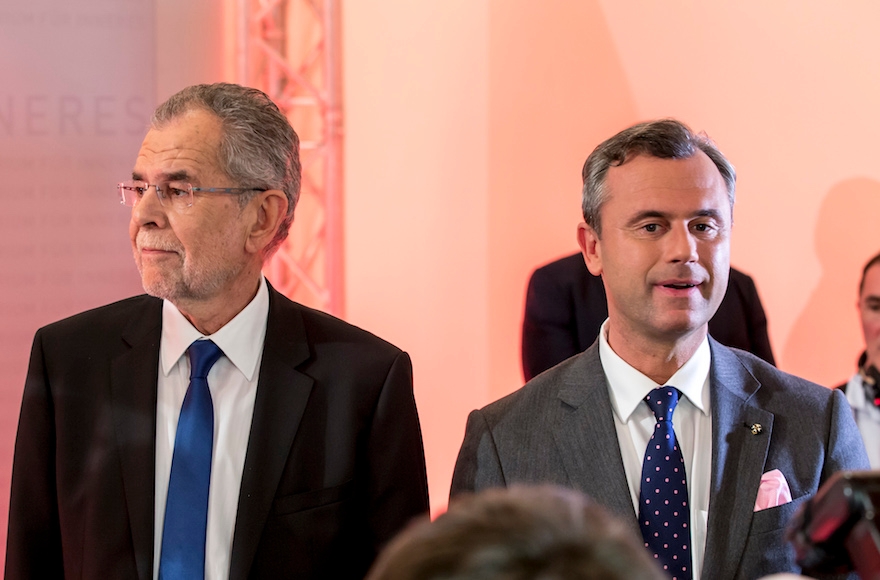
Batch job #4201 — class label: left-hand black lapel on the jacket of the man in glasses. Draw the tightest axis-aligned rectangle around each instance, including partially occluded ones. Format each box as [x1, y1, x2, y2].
[110, 300, 162, 580]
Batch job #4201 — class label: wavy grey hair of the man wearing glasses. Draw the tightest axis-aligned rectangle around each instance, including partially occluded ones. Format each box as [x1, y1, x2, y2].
[150, 83, 302, 258]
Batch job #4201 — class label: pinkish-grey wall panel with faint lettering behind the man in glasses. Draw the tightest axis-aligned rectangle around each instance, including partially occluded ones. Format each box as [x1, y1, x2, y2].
[0, 0, 155, 561]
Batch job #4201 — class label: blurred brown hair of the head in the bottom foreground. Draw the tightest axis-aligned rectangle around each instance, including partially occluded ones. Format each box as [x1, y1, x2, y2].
[367, 486, 667, 580]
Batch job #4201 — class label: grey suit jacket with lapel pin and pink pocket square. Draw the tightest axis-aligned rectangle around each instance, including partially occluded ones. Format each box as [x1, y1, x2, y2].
[451, 338, 868, 580]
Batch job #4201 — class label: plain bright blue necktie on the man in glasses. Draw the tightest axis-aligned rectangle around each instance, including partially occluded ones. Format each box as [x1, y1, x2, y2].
[159, 340, 223, 580]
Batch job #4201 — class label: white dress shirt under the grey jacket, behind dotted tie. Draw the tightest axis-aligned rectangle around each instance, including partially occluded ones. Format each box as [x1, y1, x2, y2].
[599, 320, 712, 580]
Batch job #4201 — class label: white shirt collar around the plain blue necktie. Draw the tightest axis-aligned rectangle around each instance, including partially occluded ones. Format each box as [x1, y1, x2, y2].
[159, 276, 269, 381]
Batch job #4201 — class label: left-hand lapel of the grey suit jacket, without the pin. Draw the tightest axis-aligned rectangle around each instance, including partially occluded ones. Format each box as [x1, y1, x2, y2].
[553, 343, 641, 535]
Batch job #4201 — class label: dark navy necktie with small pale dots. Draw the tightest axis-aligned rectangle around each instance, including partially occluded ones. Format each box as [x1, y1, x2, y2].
[639, 387, 693, 580]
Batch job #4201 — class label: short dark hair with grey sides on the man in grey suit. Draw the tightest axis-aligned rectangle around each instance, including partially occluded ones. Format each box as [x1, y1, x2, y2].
[581, 119, 736, 236]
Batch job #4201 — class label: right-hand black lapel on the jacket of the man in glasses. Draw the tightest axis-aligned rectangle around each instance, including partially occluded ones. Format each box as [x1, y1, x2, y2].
[229, 286, 313, 580]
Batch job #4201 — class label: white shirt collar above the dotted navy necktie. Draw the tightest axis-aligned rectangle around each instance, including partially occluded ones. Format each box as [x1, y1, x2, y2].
[599, 319, 712, 423]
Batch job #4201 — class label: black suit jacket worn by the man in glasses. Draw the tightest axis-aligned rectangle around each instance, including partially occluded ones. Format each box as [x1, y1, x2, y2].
[6, 289, 428, 580]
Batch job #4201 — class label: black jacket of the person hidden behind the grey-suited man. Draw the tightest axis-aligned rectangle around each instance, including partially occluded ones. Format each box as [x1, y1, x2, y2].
[522, 253, 776, 381]
